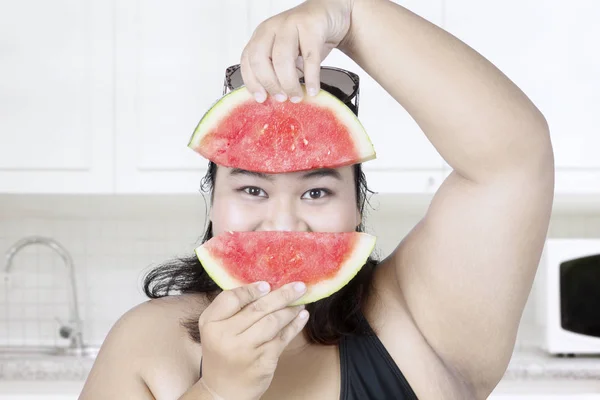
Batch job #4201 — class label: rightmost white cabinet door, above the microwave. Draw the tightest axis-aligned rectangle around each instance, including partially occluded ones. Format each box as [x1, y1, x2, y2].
[444, 0, 600, 193]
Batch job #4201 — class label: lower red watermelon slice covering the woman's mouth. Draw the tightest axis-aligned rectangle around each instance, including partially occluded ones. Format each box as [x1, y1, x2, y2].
[195, 231, 376, 304]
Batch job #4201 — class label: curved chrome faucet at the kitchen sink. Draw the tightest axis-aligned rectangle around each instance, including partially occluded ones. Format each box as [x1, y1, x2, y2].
[5, 236, 84, 353]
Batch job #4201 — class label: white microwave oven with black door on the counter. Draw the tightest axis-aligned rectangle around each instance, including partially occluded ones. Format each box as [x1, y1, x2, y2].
[537, 239, 600, 356]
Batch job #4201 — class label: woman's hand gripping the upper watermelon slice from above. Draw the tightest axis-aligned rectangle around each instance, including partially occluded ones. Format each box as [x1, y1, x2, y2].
[241, 0, 355, 103]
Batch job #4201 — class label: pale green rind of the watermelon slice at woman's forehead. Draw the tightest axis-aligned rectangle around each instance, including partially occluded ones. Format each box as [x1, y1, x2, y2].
[187, 85, 377, 169]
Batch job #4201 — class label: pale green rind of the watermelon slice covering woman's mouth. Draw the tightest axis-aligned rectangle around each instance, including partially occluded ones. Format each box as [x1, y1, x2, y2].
[195, 232, 376, 305]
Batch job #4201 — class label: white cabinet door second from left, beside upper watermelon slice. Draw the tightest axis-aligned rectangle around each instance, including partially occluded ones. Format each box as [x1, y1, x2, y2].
[116, 0, 248, 193]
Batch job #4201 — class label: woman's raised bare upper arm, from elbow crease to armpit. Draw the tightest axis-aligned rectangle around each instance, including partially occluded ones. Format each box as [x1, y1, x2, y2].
[394, 164, 554, 390]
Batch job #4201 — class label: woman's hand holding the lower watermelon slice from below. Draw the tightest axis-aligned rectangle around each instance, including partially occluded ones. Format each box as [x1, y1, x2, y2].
[198, 282, 308, 400]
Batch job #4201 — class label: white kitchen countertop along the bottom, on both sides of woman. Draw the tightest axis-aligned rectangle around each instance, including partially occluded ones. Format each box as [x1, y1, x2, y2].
[0, 345, 600, 400]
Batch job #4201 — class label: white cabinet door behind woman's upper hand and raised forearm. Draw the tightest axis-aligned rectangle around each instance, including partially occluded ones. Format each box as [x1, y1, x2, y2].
[250, 0, 443, 193]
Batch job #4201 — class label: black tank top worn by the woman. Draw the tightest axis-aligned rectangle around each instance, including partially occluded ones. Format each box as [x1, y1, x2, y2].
[200, 317, 417, 400]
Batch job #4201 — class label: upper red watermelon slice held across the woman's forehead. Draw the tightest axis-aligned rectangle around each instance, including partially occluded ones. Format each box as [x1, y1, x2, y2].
[188, 86, 376, 173]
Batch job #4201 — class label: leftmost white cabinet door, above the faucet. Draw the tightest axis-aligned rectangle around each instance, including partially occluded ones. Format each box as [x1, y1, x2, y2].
[0, 0, 113, 193]
